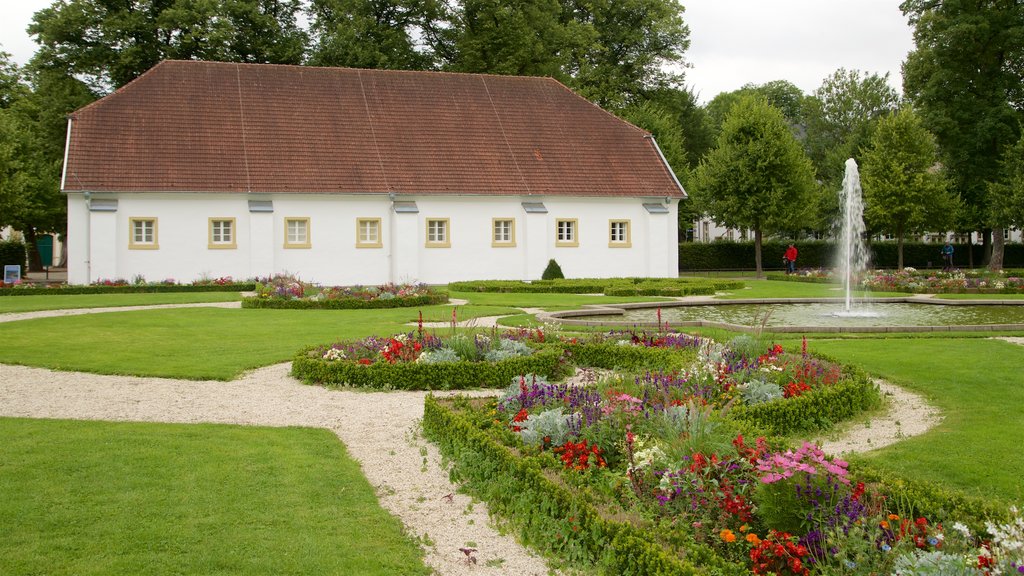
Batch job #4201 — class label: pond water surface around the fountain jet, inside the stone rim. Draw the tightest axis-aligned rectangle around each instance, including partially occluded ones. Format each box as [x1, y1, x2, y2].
[580, 303, 1024, 327]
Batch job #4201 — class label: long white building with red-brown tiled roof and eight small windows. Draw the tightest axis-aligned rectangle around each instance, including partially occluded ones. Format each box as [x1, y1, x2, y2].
[61, 61, 686, 285]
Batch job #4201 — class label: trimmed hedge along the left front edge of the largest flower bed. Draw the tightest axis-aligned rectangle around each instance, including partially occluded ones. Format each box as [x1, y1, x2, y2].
[423, 396, 748, 576]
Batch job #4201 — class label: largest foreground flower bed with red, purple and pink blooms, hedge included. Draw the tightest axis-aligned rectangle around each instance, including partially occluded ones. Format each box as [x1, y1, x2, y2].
[424, 334, 1024, 575]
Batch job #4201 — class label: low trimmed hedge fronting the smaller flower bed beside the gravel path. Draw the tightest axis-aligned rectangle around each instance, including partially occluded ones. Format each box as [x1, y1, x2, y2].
[292, 346, 567, 390]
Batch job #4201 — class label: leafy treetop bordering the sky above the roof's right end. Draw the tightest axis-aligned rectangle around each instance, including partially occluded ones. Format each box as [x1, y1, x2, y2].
[561, 0, 690, 110]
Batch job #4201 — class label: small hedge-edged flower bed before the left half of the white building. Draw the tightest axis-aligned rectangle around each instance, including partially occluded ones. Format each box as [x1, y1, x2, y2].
[242, 275, 447, 310]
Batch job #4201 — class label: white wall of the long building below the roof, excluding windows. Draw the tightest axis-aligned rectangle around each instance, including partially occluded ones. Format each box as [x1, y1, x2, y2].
[61, 194, 679, 285]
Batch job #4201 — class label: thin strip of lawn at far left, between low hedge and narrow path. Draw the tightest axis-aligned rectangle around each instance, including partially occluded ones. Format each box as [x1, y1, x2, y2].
[0, 288, 242, 314]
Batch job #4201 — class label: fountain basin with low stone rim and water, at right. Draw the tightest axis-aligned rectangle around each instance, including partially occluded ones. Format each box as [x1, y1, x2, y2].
[539, 296, 1024, 332]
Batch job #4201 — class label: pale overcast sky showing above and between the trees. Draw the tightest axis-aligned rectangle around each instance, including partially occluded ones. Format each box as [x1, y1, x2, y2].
[0, 0, 913, 101]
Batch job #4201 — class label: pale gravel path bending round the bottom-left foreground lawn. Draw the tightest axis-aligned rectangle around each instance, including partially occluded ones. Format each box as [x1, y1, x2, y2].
[0, 362, 548, 576]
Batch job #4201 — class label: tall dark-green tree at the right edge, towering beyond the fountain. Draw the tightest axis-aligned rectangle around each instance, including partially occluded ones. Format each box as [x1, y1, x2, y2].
[900, 0, 1024, 262]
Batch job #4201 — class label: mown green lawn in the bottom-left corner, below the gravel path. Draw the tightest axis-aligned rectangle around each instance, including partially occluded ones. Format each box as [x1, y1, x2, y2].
[0, 418, 430, 576]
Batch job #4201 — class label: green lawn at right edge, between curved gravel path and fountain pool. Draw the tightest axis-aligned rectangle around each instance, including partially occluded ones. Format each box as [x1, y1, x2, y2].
[798, 338, 1024, 503]
